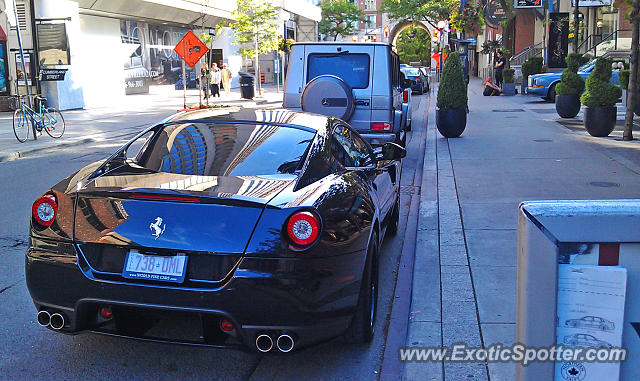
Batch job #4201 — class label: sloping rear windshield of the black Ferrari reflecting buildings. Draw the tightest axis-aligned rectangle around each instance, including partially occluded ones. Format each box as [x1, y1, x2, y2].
[138, 123, 315, 176]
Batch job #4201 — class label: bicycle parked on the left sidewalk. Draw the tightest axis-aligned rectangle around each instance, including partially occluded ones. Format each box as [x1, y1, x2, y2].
[13, 95, 65, 143]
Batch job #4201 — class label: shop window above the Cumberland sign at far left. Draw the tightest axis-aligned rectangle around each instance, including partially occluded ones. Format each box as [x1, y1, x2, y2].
[36, 23, 70, 66]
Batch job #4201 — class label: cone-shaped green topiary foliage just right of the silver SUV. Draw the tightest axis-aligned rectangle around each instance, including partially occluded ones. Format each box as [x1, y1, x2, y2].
[437, 52, 467, 109]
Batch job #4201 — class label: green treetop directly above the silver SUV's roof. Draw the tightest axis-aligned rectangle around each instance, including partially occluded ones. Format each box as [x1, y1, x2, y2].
[318, 0, 364, 41]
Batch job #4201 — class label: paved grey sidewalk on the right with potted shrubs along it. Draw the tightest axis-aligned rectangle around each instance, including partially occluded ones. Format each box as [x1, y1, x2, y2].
[405, 76, 640, 381]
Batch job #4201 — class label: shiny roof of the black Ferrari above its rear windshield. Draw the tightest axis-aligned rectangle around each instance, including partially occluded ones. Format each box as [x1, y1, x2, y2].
[164, 107, 331, 132]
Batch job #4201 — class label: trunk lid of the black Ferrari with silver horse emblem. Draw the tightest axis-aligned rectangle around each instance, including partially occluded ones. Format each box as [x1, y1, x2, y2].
[74, 167, 296, 254]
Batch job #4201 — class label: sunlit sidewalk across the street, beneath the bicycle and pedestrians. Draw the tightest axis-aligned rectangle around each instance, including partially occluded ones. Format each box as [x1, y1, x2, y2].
[0, 85, 283, 162]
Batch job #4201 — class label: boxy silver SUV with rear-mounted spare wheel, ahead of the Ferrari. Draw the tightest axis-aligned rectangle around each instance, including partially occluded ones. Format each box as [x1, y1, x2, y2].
[284, 42, 410, 146]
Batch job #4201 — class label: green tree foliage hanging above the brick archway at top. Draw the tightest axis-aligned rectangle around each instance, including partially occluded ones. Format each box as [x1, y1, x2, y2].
[379, 0, 460, 28]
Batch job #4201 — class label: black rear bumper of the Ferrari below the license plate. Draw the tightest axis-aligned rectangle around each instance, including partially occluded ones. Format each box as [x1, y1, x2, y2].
[25, 243, 366, 349]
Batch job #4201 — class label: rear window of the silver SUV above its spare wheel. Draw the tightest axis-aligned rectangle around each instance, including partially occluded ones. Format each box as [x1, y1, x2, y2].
[307, 53, 369, 89]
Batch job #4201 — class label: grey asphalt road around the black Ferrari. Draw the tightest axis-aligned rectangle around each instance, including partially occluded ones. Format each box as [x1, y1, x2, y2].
[0, 95, 428, 380]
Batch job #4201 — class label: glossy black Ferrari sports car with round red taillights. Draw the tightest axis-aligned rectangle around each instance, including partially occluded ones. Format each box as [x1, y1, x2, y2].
[25, 108, 406, 352]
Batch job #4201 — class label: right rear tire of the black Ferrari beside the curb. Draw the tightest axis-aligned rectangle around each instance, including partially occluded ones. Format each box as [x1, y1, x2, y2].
[344, 232, 378, 344]
